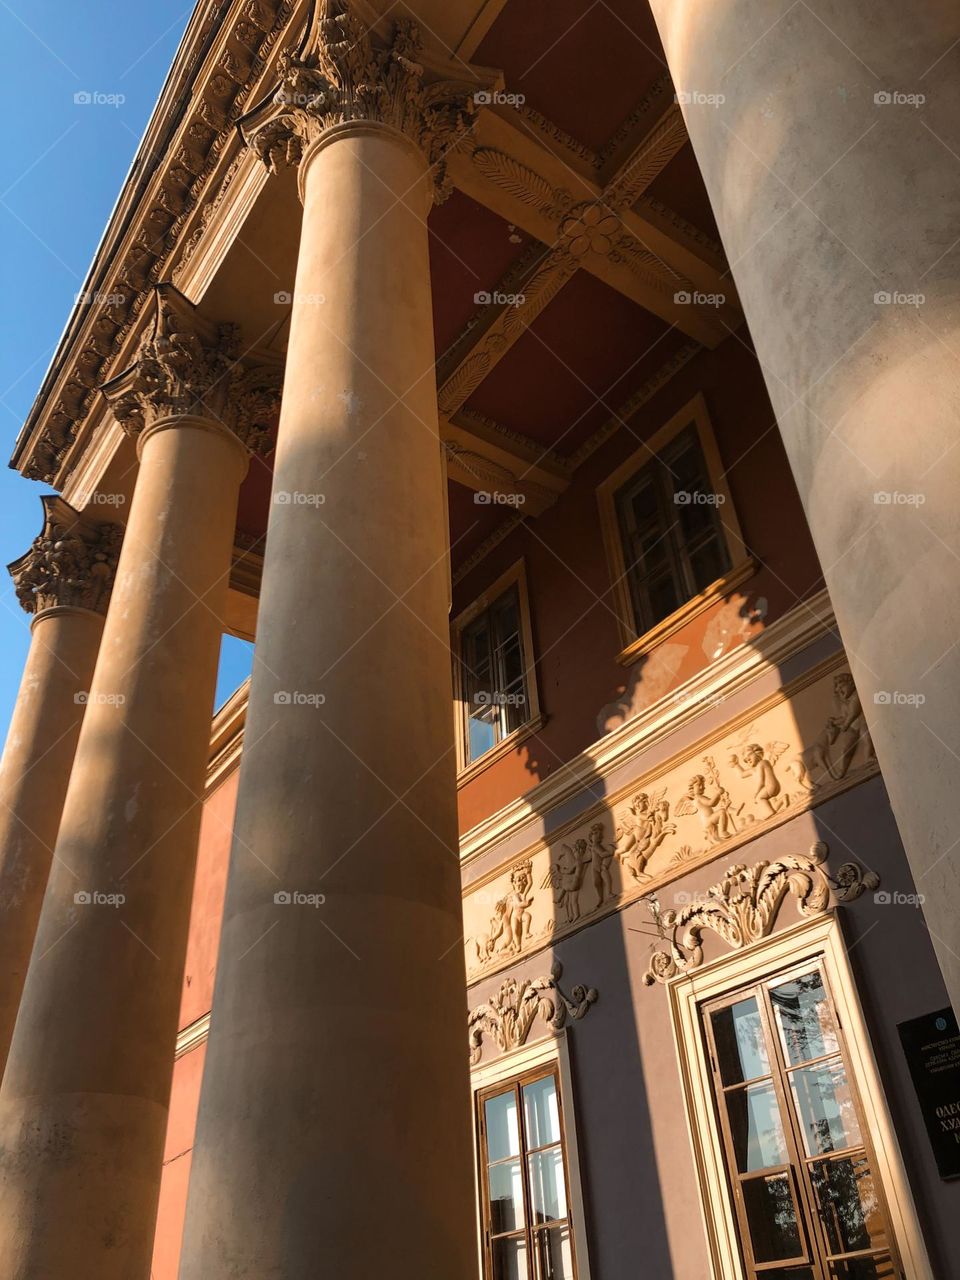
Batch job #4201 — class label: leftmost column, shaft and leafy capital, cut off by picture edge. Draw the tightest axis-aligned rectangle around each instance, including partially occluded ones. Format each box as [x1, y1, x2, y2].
[0, 495, 123, 1076]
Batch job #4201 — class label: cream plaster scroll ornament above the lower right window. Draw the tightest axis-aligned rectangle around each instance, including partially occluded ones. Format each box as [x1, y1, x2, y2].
[643, 841, 879, 987]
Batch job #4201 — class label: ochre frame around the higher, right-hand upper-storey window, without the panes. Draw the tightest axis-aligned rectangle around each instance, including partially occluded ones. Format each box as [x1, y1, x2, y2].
[596, 393, 756, 666]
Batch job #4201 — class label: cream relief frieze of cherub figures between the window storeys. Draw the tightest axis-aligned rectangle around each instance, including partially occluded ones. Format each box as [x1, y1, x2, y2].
[463, 655, 877, 982]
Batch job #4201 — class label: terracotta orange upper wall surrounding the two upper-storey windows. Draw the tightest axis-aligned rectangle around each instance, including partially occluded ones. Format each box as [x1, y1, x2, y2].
[453, 330, 822, 831]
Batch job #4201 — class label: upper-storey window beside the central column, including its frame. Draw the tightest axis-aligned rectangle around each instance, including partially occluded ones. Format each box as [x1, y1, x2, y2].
[453, 562, 540, 771]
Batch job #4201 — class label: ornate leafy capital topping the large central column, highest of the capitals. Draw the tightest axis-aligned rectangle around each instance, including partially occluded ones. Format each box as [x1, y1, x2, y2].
[239, 0, 484, 200]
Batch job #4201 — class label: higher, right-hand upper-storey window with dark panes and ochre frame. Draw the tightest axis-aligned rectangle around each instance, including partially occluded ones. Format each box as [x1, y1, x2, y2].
[598, 396, 753, 662]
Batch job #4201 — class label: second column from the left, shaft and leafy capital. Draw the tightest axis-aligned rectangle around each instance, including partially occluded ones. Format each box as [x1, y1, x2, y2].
[0, 285, 277, 1280]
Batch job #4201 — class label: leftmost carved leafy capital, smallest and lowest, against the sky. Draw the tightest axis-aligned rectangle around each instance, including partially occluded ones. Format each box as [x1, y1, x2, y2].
[8, 494, 123, 613]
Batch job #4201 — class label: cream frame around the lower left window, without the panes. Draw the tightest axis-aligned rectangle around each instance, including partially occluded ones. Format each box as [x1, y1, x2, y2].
[470, 1029, 590, 1280]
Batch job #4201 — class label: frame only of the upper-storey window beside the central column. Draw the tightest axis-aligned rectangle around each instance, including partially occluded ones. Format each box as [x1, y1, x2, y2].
[451, 558, 544, 787]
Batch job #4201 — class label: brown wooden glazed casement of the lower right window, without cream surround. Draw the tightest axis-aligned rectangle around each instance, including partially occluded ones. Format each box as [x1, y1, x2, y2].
[703, 961, 901, 1280]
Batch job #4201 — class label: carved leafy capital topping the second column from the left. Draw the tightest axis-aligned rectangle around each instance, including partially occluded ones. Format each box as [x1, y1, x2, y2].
[101, 282, 282, 453]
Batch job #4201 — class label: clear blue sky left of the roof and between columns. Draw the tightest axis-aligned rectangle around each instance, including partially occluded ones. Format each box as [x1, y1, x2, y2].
[0, 0, 256, 741]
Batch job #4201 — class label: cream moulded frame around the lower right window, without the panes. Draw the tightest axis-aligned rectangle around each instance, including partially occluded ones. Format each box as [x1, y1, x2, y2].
[667, 913, 934, 1280]
